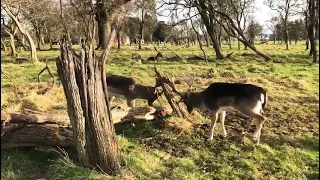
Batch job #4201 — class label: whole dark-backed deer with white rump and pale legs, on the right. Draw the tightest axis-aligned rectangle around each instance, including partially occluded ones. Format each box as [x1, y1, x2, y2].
[180, 82, 268, 144]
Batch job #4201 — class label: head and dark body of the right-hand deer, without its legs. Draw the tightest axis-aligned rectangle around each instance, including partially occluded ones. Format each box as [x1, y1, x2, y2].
[182, 83, 267, 112]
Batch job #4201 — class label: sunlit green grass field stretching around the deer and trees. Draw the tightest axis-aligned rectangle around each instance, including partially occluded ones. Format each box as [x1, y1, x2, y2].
[1, 42, 319, 180]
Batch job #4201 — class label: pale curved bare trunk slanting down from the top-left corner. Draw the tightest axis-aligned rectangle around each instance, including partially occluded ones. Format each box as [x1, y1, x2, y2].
[1, 3, 39, 63]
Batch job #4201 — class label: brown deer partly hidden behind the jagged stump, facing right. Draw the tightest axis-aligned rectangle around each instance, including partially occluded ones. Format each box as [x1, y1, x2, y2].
[106, 75, 163, 108]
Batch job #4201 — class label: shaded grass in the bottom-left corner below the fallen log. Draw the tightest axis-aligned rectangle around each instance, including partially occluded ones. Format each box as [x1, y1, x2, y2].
[1, 148, 108, 180]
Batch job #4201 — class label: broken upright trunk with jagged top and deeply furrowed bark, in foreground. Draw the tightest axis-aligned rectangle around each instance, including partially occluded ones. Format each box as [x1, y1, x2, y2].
[57, 32, 120, 175]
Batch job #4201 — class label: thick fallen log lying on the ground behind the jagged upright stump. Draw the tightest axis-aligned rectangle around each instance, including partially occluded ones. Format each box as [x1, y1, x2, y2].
[1, 106, 172, 149]
